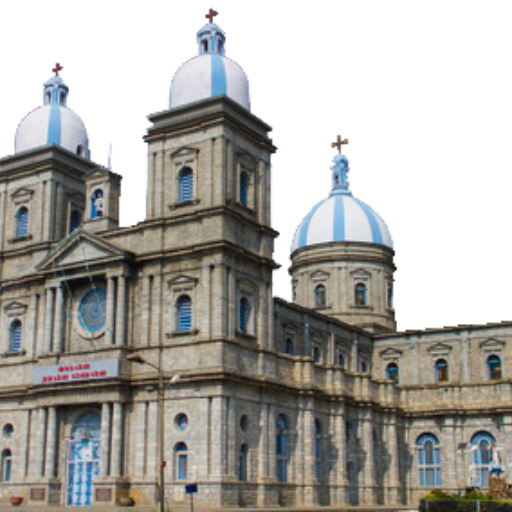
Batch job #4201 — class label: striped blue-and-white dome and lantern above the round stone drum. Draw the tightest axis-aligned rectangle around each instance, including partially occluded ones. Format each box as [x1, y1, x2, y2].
[291, 155, 393, 253]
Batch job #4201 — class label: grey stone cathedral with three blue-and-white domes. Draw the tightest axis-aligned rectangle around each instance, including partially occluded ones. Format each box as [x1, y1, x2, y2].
[0, 12, 512, 508]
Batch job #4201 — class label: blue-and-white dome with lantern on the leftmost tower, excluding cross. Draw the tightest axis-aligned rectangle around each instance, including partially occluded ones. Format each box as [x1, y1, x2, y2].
[14, 76, 90, 158]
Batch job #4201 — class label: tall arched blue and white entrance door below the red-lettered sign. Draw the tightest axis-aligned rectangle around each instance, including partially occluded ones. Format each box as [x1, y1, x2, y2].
[66, 413, 101, 507]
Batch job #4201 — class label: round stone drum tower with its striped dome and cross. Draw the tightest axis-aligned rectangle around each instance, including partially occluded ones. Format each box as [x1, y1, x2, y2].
[290, 137, 396, 332]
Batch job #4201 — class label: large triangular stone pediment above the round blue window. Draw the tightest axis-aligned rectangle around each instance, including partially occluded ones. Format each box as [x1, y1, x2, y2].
[37, 229, 132, 272]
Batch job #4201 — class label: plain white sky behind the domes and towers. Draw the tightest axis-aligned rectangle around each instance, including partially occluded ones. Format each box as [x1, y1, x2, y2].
[0, 0, 512, 330]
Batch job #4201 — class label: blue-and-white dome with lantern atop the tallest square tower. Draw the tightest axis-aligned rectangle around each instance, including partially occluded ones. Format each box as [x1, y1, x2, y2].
[169, 23, 251, 110]
